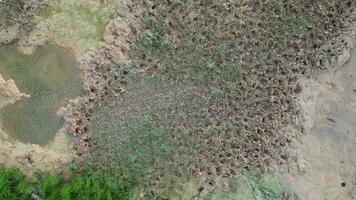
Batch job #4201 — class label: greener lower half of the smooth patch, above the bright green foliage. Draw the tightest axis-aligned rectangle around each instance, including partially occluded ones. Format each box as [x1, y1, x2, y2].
[90, 111, 174, 174]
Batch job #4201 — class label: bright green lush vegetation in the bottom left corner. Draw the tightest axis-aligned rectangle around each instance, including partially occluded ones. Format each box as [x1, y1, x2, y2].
[0, 168, 138, 200]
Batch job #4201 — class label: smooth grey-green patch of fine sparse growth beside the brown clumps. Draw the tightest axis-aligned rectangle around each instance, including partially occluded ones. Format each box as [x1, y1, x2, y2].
[87, 77, 186, 179]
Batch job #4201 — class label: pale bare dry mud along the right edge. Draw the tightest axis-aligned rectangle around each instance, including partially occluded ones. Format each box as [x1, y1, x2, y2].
[286, 29, 356, 200]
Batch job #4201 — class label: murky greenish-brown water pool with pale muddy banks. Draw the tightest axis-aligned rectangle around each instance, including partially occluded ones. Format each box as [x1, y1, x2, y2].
[0, 44, 83, 145]
